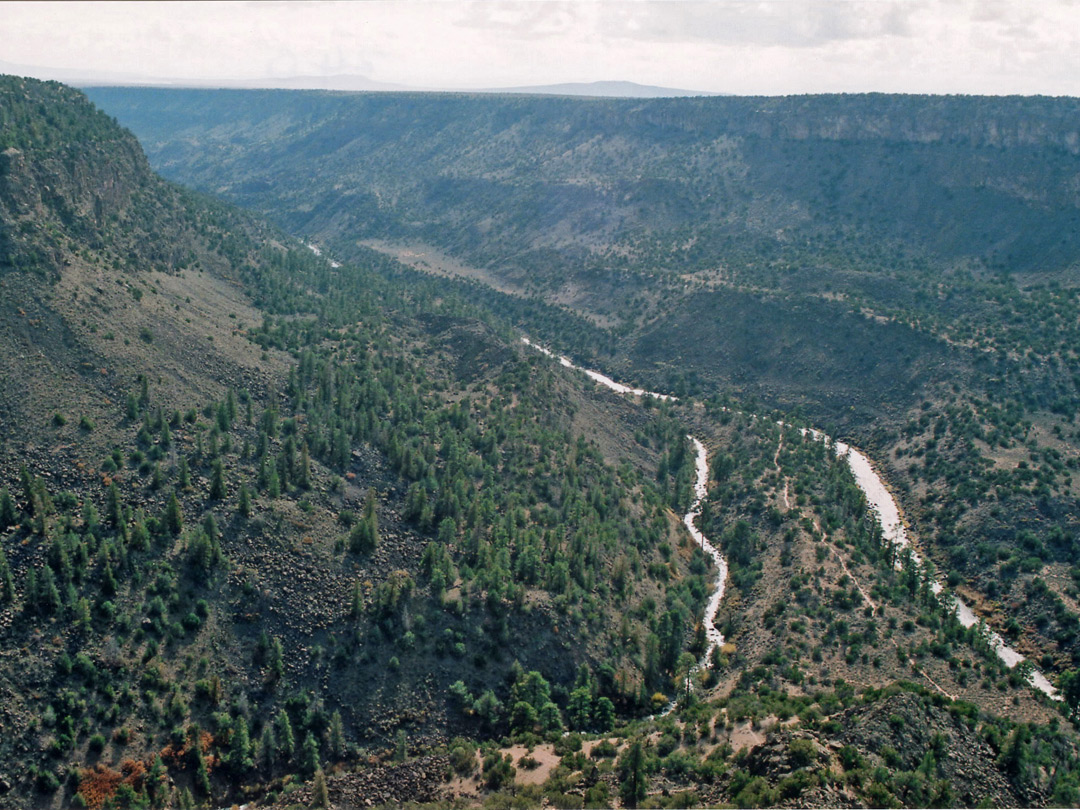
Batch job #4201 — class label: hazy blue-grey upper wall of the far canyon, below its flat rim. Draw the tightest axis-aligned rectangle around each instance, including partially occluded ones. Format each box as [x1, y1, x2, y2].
[91, 87, 1080, 278]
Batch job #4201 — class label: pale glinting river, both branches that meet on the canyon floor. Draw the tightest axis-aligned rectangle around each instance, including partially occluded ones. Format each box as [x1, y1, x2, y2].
[522, 337, 1062, 714]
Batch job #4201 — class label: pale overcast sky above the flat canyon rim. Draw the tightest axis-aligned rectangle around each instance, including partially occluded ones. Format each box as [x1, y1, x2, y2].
[0, 0, 1080, 96]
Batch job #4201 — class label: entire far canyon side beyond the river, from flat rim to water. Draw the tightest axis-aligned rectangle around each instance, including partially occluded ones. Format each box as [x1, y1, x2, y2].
[86, 89, 1080, 691]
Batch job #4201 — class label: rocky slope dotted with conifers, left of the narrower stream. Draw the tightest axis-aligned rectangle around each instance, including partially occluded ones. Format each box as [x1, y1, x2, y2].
[0, 77, 707, 807]
